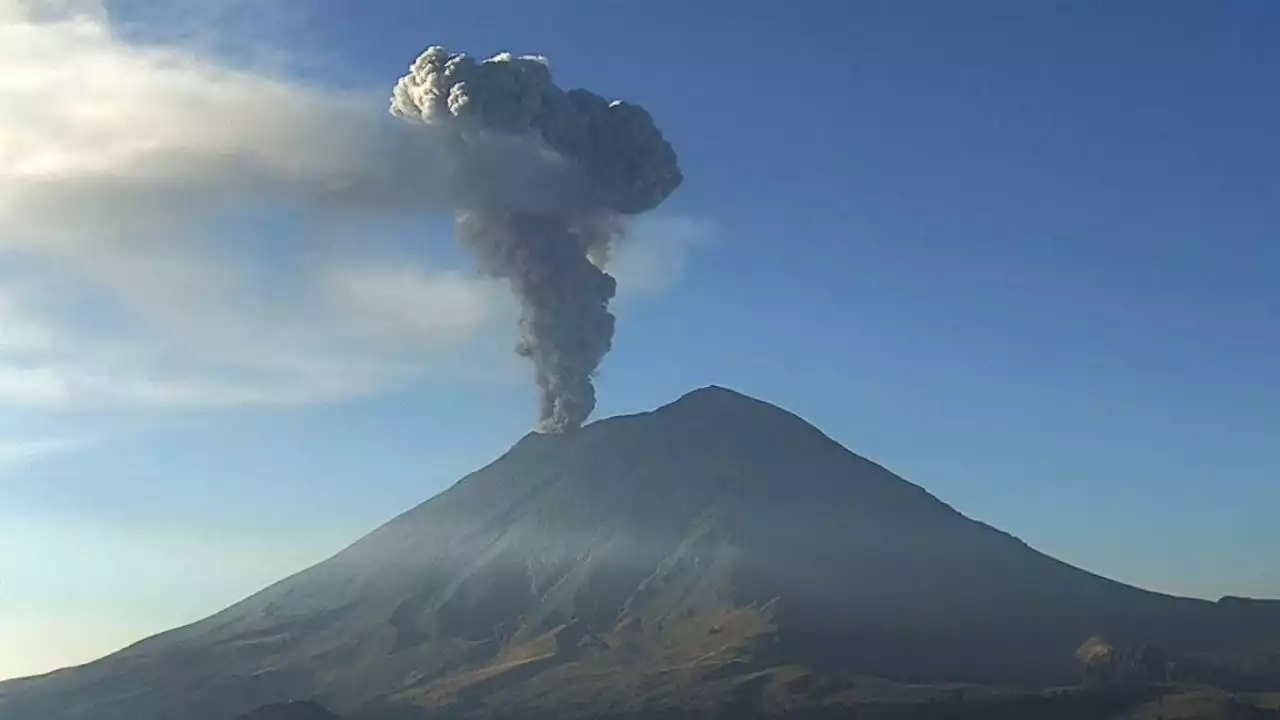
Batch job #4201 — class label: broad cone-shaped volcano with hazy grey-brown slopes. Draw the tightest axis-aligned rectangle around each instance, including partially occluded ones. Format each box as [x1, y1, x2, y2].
[0, 387, 1280, 720]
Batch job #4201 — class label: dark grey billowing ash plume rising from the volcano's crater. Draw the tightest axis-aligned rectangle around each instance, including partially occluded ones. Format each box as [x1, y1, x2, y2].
[390, 47, 682, 432]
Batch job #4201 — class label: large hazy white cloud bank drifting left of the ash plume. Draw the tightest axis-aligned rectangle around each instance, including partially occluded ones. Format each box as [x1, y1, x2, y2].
[0, 0, 503, 407]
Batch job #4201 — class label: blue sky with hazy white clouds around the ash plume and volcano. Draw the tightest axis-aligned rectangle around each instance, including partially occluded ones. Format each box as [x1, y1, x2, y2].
[0, 0, 1280, 676]
